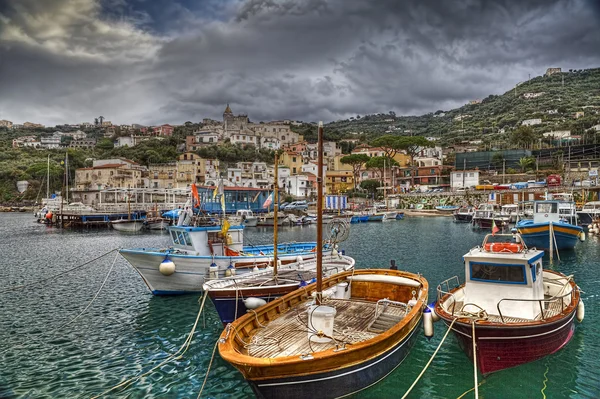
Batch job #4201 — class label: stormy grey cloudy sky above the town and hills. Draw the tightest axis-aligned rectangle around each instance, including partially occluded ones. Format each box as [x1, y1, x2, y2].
[0, 0, 600, 125]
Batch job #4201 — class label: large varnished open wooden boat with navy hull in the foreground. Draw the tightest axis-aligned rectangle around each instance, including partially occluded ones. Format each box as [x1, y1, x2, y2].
[218, 269, 428, 399]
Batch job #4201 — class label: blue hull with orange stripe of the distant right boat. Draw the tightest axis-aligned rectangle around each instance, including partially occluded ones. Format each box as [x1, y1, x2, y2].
[517, 221, 583, 250]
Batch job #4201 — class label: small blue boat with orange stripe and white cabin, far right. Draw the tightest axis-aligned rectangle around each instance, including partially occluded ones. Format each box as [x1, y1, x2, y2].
[517, 201, 583, 250]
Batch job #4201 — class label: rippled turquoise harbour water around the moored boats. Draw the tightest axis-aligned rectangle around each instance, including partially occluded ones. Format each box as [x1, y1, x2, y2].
[0, 214, 600, 398]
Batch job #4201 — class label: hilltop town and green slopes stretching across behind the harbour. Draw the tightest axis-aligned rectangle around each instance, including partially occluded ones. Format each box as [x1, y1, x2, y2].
[0, 68, 600, 205]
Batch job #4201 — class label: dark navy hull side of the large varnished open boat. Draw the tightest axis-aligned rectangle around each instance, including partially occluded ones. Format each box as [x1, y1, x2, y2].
[248, 318, 420, 399]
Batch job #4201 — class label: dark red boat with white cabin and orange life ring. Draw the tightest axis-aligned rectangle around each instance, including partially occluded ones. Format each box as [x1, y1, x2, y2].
[435, 234, 584, 374]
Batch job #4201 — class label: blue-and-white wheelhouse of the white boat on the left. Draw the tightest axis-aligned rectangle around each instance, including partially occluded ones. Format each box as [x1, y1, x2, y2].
[169, 226, 244, 256]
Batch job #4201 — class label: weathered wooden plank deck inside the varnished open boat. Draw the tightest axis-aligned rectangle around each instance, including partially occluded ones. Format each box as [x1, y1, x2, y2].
[245, 299, 408, 358]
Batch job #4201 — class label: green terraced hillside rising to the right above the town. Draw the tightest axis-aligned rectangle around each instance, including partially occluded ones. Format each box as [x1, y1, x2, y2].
[298, 68, 600, 144]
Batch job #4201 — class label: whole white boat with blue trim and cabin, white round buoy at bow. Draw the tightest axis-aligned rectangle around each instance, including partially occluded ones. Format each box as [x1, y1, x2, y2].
[120, 225, 331, 295]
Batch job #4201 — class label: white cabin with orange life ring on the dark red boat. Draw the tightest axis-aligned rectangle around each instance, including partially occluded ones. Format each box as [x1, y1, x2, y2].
[457, 234, 544, 319]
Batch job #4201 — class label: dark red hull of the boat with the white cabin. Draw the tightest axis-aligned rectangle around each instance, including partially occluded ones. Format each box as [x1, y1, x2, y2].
[444, 310, 575, 374]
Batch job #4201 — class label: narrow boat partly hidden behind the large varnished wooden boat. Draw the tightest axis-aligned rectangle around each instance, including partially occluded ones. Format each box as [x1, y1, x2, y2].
[202, 254, 354, 324]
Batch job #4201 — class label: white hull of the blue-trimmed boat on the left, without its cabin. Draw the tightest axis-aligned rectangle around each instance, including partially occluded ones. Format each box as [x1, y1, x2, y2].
[120, 248, 331, 295]
